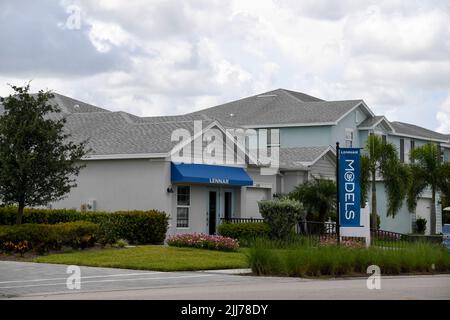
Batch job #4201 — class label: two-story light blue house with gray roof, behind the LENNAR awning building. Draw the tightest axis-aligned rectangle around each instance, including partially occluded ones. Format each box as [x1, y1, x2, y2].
[189, 89, 450, 233]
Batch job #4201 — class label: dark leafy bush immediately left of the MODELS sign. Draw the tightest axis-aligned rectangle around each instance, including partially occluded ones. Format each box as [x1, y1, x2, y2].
[289, 179, 336, 221]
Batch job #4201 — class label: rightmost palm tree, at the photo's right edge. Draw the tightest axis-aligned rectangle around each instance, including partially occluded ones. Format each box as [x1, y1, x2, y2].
[408, 143, 450, 234]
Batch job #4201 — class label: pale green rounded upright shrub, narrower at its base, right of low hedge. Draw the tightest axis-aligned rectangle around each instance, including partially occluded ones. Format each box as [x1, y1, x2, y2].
[258, 199, 303, 239]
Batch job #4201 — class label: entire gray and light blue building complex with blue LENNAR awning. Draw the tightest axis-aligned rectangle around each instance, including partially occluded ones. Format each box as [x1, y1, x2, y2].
[0, 89, 450, 234]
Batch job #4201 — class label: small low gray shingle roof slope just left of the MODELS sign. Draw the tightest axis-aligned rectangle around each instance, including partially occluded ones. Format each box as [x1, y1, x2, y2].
[280, 146, 330, 170]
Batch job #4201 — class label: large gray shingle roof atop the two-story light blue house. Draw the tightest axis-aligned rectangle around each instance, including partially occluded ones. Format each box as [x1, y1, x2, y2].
[187, 89, 373, 127]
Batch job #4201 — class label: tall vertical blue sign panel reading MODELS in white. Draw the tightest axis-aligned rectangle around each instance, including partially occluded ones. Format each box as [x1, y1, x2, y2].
[339, 148, 361, 227]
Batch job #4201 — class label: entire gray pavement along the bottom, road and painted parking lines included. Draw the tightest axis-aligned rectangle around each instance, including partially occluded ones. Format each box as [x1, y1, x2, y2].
[0, 261, 450, 300]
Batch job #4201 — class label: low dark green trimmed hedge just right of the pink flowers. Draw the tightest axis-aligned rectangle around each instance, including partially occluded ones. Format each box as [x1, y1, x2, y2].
[218, 222, 269, 245]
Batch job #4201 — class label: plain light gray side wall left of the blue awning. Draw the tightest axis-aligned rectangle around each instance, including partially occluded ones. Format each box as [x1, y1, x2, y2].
[52, 159, 171, 212]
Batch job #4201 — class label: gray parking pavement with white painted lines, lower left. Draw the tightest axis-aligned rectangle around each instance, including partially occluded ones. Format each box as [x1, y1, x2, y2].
[0, 261, 246, 298]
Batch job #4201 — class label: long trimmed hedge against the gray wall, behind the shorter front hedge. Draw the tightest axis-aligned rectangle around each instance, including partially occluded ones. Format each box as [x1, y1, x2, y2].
[0, 207, 169, 244]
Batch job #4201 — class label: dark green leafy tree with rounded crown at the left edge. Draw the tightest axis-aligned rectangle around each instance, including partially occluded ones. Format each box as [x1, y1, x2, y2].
[0, 84, 87, 224]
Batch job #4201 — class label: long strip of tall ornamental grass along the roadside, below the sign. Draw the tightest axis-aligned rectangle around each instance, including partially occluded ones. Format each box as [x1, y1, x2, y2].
[248, 241, 450, 277]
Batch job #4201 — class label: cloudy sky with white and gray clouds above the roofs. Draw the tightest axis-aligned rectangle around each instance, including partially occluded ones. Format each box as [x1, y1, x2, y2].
[0, 0, 450, 133]
